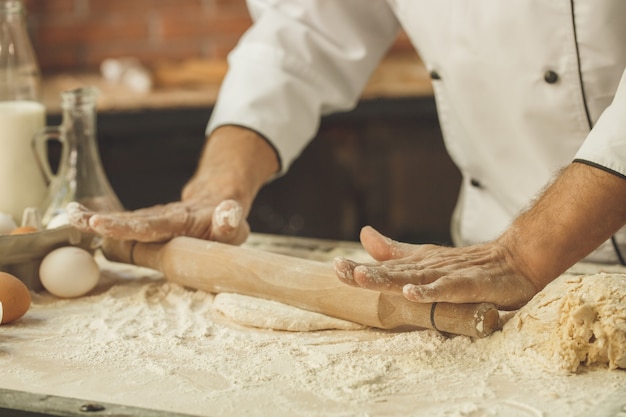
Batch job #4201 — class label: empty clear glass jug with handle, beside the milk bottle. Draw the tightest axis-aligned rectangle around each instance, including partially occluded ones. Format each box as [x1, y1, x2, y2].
[33, 87, 124, 227]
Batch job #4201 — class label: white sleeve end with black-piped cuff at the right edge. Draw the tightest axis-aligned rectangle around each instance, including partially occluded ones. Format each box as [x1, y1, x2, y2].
[575, 72, 626, 177]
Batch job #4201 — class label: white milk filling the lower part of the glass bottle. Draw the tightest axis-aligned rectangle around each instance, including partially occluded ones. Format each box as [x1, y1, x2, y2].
[0, 101, 47, 224]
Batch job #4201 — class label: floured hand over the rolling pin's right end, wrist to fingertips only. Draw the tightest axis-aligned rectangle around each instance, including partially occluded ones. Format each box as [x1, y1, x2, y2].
[335, 227, 538, 309]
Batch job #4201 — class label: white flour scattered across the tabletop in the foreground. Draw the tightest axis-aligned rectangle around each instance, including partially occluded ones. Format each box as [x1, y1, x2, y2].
[0, 249, 626, 417]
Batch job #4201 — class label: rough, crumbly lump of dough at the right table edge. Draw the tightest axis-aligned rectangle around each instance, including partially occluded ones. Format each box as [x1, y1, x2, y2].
[503, 273, 626, 372]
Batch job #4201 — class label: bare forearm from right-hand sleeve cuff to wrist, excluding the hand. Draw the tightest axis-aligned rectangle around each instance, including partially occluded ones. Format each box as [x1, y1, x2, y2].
[498, 163, 626, 290]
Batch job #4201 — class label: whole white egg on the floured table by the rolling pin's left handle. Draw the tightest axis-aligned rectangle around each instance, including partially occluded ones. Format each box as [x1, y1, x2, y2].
[39, 246, 100, 298]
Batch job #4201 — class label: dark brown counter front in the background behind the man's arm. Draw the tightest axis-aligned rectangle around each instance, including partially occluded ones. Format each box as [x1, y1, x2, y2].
[48, 97, 460, 244]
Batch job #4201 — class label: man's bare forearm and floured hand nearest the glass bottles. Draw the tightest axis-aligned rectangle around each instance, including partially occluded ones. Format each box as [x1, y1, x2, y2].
[67, 126, 279, 244]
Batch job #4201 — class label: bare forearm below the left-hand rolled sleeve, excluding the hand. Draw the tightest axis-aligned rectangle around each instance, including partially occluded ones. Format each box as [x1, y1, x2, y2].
[182, 126, 279, 209]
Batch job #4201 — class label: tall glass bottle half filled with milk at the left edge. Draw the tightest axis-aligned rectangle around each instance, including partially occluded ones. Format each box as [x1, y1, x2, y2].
[0, 0, 47, 224]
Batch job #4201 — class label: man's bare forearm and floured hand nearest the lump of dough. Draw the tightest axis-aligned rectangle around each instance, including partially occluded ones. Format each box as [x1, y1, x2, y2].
[335, 162, 626, 309]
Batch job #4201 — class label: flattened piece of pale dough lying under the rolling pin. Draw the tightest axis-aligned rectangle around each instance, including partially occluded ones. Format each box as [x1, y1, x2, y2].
[213, 293, 366, 332]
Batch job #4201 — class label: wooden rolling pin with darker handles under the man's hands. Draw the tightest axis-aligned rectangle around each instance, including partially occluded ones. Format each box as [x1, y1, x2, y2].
[102, 236, 500, 338]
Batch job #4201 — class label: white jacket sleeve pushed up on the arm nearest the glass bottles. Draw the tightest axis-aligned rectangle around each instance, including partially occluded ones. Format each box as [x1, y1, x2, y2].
[207, 0, 399, 172]
